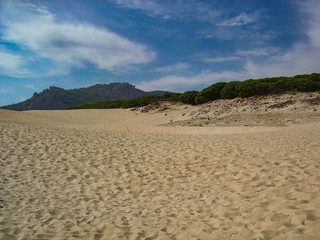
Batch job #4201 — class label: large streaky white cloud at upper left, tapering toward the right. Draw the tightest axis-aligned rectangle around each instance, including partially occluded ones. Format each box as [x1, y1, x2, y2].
[1, 2, 155, 76]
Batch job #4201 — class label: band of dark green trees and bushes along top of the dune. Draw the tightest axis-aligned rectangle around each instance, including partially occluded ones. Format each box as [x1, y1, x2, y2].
[67, 73, 320, 109]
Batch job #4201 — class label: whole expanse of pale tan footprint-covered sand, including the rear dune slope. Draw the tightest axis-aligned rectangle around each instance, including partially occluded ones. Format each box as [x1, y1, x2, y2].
[0, 93, 320, 239]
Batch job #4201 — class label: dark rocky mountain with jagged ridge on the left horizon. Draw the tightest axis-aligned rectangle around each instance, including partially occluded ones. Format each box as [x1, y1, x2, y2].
[0, 83, 165, 111]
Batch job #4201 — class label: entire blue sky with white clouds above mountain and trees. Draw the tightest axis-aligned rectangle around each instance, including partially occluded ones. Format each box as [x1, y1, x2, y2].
[0, 0, 320, 106]
